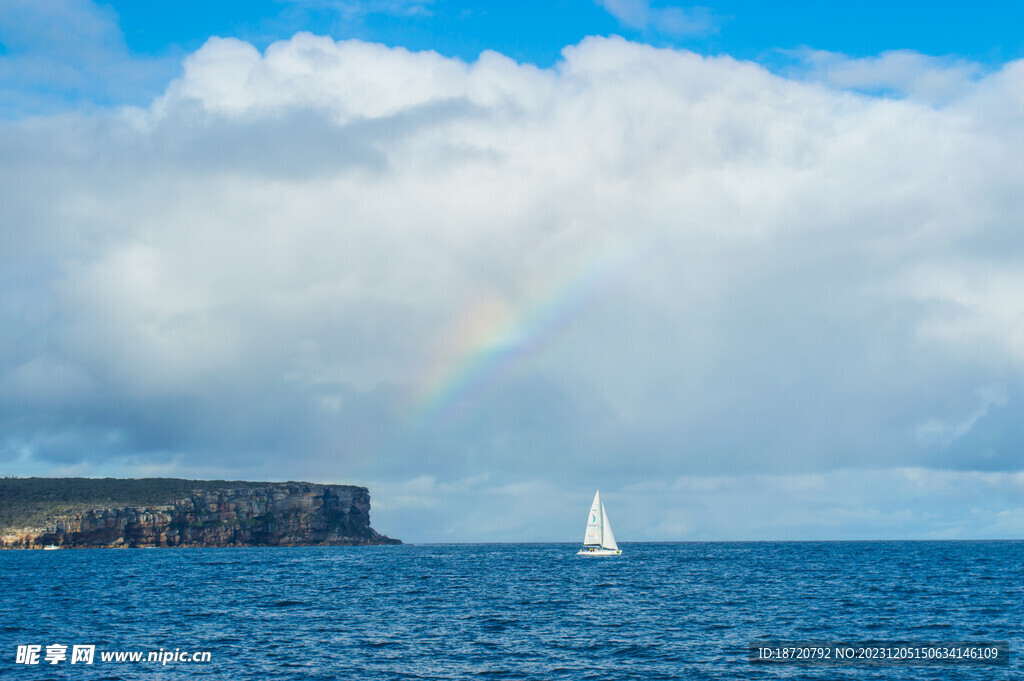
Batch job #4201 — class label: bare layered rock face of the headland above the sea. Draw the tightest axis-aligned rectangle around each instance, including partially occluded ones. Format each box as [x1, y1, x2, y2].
[0, 482, 401, 549]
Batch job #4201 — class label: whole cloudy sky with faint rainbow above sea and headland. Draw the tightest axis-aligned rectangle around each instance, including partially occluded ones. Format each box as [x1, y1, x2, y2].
[0, 0, 1024, 543]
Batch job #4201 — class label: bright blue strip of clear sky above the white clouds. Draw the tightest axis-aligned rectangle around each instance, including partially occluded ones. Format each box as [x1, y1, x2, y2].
[90, 0, 1024, 67]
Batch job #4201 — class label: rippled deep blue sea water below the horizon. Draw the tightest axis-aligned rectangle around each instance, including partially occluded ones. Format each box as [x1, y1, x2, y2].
[0, 542, 1024, 681]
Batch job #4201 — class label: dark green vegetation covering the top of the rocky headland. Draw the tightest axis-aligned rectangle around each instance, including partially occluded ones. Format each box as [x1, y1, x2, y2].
[0, 477, 274, 529]
